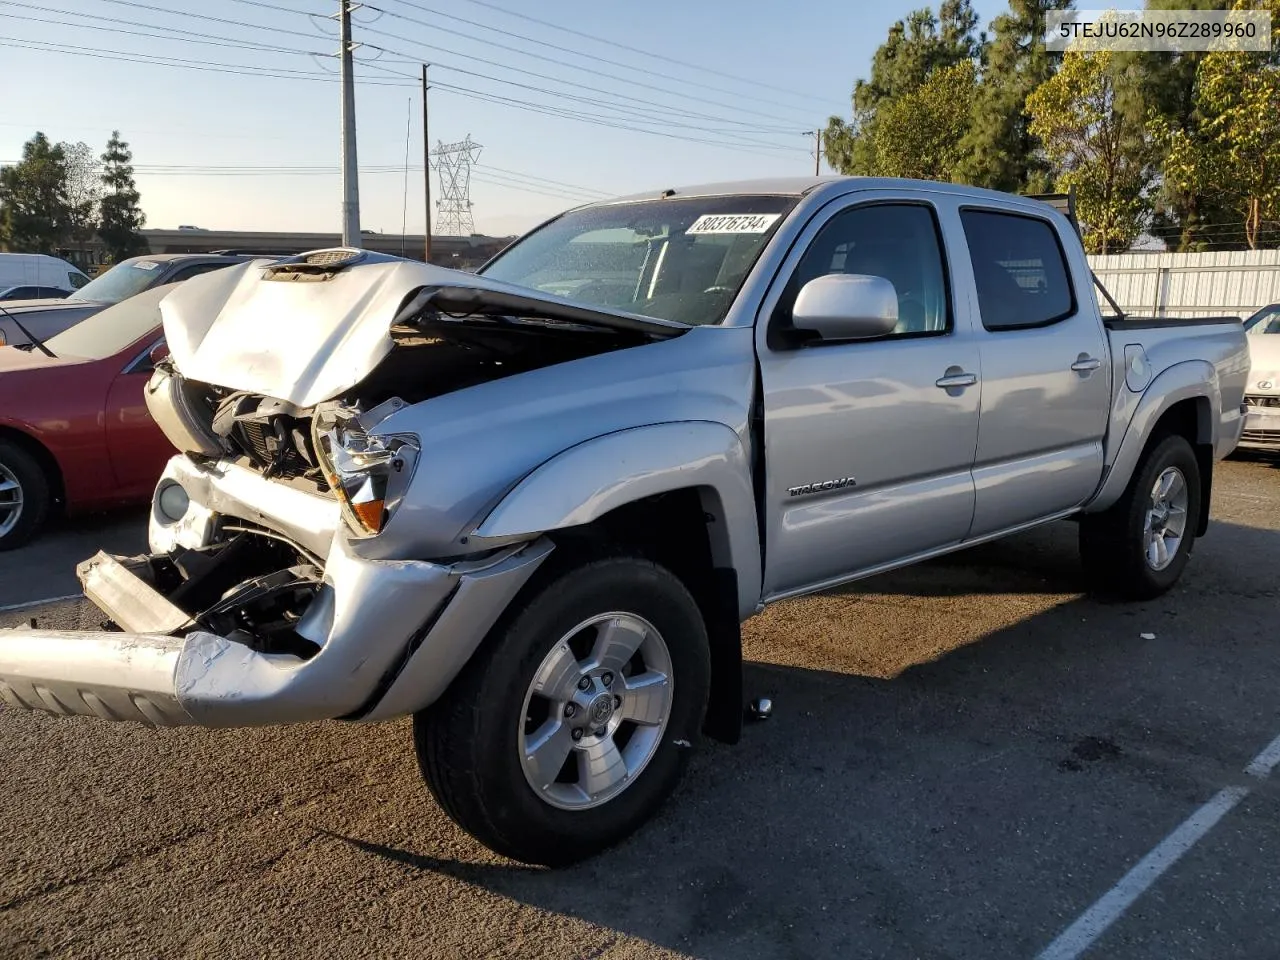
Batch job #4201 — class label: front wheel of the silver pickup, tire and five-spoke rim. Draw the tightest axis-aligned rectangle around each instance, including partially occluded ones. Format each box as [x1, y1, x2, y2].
[413, 557, 710, 865]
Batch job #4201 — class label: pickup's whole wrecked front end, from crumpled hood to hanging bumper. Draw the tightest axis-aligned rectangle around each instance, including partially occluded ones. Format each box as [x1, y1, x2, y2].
[0, 248, 684, 727]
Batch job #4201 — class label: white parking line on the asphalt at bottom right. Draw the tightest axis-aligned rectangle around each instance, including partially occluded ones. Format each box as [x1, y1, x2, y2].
[1037, 737, 1280, 960]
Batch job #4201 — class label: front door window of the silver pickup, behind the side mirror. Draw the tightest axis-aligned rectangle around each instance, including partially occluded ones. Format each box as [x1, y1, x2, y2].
[772, 204, 951, 337]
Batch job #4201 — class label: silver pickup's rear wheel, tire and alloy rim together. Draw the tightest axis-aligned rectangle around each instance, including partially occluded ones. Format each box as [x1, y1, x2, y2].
[1080, 435, 1201, 600]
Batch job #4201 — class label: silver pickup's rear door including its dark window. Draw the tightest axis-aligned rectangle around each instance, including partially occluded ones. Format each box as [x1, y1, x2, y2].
[960, 206, 1111, 538]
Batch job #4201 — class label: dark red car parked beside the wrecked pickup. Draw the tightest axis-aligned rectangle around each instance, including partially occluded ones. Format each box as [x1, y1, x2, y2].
[0, 287, 174, 550]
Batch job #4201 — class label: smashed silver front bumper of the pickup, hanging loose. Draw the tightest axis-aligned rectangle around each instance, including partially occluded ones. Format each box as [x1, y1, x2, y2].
[0, 458, 550, 727]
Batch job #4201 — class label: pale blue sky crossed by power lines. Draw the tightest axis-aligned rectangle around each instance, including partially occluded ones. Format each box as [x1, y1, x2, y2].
[0, 0, 1029, 234]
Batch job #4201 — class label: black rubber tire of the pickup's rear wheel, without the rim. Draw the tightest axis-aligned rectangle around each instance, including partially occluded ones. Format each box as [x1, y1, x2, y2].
[1080, 434, 1203, 600]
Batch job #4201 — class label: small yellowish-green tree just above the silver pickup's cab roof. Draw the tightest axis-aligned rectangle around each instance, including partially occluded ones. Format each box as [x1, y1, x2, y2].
[873, 60, 977, 180]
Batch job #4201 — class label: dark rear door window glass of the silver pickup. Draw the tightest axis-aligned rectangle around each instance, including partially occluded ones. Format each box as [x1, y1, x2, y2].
[960, 210, 1075, 330]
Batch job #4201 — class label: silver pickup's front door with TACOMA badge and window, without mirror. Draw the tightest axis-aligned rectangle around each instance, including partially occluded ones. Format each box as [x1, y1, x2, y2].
[756, 198, 980, 599]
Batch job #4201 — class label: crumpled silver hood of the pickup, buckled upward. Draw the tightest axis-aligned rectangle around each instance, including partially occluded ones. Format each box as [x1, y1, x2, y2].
[160, 253, 687, 407]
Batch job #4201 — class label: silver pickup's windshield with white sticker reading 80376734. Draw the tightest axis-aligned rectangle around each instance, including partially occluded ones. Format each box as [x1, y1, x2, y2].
[480, 196, 796, 324]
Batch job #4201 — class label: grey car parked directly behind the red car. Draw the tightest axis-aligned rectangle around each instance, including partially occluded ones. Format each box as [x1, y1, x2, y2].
[0, 253, 270, 346]
